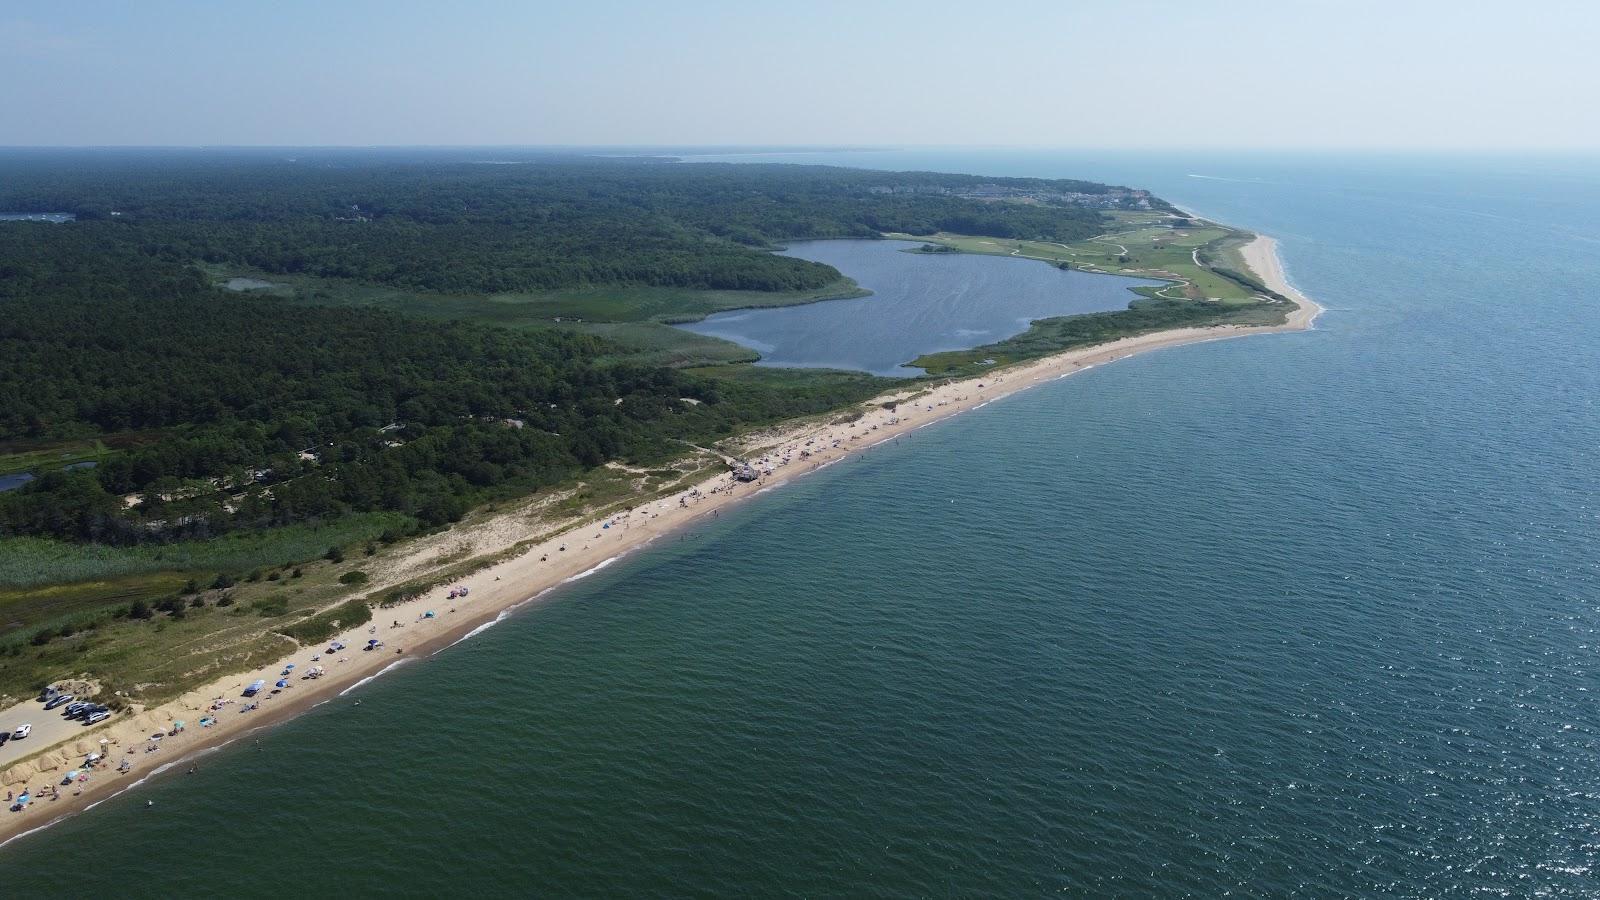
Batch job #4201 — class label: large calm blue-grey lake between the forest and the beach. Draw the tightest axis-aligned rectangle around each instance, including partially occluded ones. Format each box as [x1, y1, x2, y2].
[683, 240, 1162, 376]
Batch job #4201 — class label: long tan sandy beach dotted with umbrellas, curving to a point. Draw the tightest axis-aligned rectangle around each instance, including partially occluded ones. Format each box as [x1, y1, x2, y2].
[0, 237, 1322, 847]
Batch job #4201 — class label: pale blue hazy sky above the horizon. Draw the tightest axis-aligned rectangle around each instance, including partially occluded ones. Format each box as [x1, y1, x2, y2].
[0, 0, 1600, 149]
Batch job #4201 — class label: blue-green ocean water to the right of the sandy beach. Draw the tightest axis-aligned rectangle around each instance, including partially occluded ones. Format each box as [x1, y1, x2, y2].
[0, 152, 1600, 897]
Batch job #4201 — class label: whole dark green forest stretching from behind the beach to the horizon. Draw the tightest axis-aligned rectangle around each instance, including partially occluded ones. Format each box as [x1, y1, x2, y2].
[0, 151, 1149, 544]
